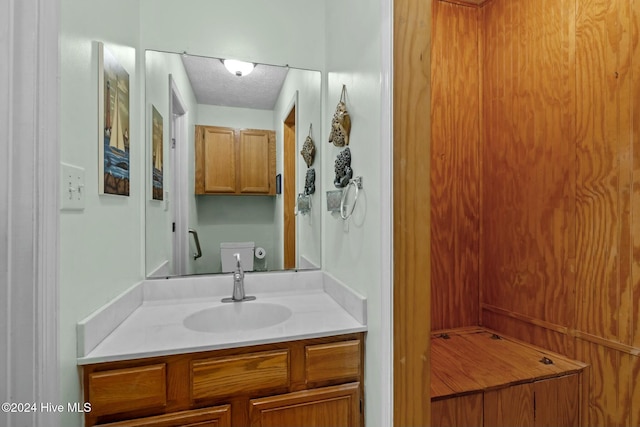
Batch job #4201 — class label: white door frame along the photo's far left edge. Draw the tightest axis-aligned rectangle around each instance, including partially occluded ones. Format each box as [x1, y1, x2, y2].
[0, 0, 60, 427]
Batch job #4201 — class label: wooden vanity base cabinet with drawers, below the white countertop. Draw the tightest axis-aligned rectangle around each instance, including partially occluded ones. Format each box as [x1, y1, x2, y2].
[83, 333, 364, 427]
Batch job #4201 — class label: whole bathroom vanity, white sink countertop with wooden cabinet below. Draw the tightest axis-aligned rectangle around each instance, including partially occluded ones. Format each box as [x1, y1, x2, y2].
[78, 271, 366, 427]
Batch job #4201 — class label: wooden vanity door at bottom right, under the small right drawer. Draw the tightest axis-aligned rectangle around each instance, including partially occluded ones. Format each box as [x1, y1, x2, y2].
[249, 383, 362, 427]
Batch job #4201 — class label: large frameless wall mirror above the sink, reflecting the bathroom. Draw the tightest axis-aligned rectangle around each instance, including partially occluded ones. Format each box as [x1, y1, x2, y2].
[145, 51, 321, 277]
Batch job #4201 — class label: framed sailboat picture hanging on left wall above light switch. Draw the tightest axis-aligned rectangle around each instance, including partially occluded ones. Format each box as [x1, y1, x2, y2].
[98, 43, 130, 196]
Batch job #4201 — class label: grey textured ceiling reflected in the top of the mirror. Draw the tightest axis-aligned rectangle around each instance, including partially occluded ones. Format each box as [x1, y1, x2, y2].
[182, 55, 289, 110]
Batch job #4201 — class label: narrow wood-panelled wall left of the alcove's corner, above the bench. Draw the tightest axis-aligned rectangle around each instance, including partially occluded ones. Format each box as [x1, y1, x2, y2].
[431, 1, 480, 330]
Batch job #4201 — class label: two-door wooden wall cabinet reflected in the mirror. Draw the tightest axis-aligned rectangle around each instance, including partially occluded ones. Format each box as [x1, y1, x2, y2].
[195, 126, 276, 195]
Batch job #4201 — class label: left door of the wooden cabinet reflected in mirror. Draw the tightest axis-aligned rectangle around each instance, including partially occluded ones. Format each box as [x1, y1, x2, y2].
[196, 126, 237, 194]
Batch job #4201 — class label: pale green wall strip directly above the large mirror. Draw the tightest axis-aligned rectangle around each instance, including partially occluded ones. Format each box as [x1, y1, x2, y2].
[140, 0, 325, 70]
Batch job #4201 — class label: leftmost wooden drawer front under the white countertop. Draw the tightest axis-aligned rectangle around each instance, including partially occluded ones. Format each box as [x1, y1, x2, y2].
[89, 363, 167, 416]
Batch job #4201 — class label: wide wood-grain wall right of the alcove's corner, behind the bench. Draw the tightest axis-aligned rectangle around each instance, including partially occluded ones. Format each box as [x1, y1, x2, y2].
[476, 0, 640, 426]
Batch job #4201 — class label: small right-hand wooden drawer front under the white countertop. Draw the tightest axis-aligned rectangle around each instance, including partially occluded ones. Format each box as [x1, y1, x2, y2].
[305, 340, 361, 383]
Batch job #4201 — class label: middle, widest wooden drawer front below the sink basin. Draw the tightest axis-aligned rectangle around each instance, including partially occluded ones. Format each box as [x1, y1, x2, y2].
[191, 350, 289, 400]
